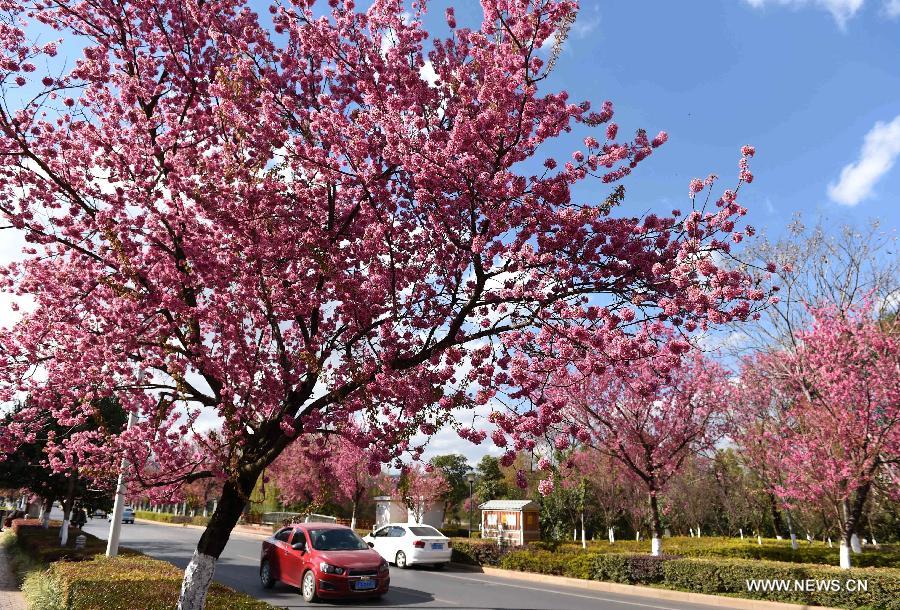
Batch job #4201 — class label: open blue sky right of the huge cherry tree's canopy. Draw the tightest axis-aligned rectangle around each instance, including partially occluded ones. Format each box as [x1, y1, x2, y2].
[450, 0, 900, 241]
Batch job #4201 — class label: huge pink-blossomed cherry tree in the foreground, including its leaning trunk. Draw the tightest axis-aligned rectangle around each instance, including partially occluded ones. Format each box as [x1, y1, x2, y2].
[0, 0, 764, 610]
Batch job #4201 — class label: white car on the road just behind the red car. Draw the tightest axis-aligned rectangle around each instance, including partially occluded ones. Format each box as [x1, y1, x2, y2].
[363, 523, 453, 568]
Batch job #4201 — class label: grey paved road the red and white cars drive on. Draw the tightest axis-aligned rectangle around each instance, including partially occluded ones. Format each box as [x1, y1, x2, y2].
[54, 508, 744, 610]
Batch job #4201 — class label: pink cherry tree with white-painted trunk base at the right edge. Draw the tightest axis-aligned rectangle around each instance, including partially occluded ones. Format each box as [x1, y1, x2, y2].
[745, 307, 900, 568]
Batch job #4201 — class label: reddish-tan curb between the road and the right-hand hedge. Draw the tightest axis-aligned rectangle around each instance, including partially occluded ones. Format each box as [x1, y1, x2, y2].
[451, 563, 833, 610]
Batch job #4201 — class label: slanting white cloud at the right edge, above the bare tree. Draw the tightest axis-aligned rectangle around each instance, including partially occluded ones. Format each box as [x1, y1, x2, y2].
[828, 116, 900, 206]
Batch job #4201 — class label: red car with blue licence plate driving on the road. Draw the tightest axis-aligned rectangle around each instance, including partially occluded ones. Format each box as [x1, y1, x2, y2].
[259, 523, 391, 602]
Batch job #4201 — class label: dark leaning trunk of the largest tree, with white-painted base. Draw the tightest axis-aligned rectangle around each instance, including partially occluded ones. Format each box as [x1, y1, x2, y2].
[177, 471, 260, 610]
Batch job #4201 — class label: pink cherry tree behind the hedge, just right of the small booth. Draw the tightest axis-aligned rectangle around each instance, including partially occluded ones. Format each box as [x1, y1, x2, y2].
[512, 353, 730, 555]
